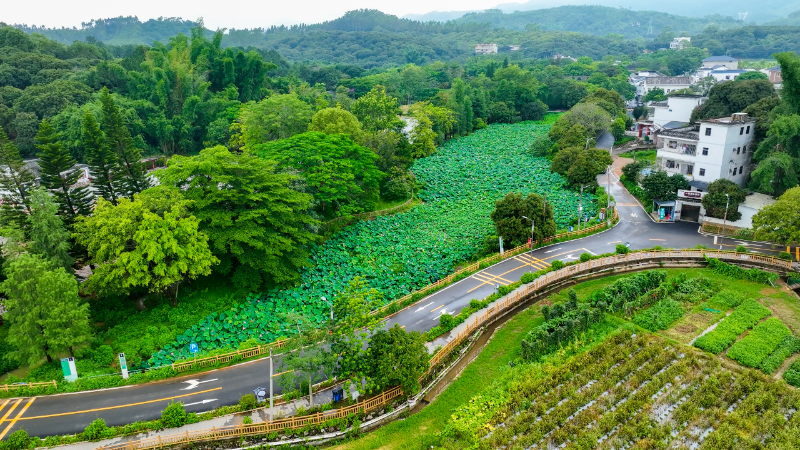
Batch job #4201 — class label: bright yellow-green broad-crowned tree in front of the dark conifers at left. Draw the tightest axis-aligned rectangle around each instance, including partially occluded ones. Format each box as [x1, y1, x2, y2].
[75, 186, 218, 306]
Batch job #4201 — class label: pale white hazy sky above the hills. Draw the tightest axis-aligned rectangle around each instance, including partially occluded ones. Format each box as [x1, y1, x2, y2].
[0, 0, 500, 29]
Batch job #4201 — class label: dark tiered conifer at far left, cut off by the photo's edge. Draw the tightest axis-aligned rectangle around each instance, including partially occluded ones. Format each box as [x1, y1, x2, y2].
[0, 128, 34, 227]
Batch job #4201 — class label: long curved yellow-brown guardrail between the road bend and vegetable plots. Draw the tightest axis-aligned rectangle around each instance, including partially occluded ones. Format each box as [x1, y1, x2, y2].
[429, 249, 792, 370]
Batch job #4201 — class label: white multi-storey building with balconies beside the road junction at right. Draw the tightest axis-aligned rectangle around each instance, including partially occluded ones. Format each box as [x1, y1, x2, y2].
[656, 113, 756, 190]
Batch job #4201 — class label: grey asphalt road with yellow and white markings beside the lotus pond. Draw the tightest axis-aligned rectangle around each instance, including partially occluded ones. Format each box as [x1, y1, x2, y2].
[0, 170, 763, 438]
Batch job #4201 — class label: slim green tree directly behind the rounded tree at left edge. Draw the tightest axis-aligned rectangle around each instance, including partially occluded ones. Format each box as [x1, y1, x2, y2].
[26, 188, 74, 273]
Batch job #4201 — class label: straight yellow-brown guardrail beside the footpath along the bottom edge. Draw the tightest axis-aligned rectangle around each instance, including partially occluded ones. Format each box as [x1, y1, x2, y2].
[98, 386, 403, 450]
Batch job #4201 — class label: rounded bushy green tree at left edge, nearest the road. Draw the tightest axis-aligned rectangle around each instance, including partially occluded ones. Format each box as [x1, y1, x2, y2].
[0, 253, 90, 365]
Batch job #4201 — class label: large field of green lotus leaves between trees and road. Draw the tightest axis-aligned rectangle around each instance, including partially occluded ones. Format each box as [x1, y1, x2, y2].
[149, 122, 596, 366]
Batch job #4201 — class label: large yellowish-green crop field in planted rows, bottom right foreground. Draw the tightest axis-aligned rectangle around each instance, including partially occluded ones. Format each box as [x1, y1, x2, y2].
[460, 331, 800, 450]
